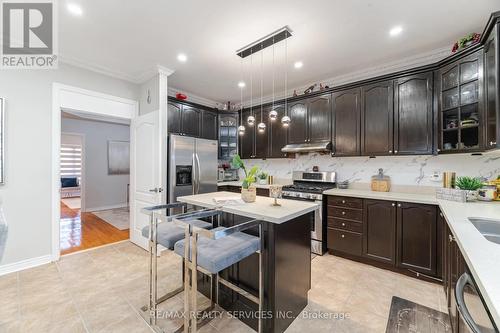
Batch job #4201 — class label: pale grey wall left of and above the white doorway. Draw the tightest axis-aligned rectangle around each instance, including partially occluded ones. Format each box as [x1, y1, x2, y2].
[0, 64, 139, 270]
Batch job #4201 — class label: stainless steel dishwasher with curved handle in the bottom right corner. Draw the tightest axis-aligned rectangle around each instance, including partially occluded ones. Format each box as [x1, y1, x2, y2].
[454, 272, 498, 333]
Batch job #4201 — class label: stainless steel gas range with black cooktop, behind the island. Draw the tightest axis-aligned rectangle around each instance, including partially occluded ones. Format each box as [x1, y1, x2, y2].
[283, 171, 336, 255]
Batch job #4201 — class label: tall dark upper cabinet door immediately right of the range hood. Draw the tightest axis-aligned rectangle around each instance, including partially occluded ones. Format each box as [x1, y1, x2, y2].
[332, 88, 361, 156]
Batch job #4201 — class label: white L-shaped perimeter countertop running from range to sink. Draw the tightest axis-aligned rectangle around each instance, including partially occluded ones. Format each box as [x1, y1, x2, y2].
[323, 185, 500, 327]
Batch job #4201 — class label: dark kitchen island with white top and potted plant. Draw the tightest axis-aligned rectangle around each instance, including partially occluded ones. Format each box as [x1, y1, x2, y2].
[177, 192, 320, 332]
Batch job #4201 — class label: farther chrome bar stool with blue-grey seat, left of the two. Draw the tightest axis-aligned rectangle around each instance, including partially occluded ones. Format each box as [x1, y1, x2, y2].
[141, 203, 218, 325]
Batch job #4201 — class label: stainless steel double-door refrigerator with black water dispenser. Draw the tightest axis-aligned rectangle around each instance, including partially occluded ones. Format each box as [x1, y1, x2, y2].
[167, 134, 217, 203]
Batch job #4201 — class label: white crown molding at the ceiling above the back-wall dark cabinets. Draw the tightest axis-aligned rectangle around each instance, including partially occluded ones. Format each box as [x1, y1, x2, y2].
[243, 46, 451, 107]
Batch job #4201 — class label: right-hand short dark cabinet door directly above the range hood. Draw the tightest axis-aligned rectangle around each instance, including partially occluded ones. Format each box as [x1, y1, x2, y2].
[307, 94, 332, 142]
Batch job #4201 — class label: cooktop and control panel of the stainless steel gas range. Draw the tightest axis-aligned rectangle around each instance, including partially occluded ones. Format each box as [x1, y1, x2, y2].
[283, 171, 335, 201]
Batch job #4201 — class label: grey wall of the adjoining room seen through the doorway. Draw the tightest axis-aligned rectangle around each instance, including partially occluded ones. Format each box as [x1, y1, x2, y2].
[61, 118, 130, 211]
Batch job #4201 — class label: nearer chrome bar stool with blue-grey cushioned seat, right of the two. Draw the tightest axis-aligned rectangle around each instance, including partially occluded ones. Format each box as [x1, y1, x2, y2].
[173, 217, 264, 333]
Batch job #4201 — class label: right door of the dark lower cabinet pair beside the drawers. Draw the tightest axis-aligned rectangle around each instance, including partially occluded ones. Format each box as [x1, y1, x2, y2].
[396, 202, 437, 276]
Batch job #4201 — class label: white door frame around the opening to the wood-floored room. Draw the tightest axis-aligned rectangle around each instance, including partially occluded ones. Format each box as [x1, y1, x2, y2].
[51, 83, 139, 261]
